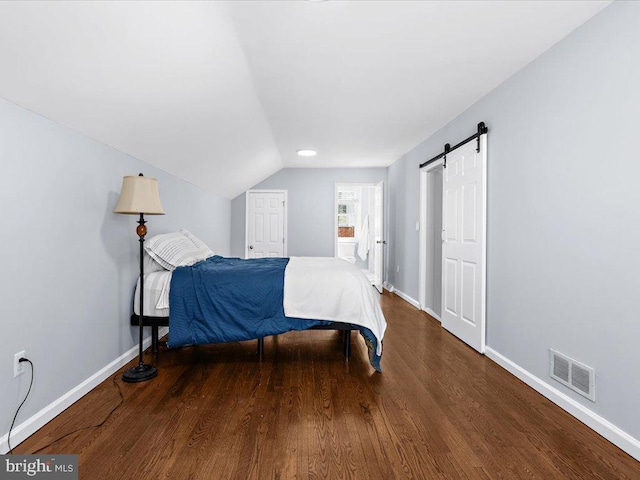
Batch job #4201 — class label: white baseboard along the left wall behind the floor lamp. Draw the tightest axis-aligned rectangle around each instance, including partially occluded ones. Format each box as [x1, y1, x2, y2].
[0, 327, 169, 454]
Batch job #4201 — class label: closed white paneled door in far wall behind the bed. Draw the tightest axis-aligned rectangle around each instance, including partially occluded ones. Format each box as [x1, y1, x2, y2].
[245, 191, 286, 258]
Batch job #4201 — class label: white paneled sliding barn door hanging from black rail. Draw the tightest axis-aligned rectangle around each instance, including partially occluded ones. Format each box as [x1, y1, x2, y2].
[441, 135, 487, 353]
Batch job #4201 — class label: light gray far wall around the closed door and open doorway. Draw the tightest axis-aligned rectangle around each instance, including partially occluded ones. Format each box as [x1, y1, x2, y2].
[231, 168, 387, 257]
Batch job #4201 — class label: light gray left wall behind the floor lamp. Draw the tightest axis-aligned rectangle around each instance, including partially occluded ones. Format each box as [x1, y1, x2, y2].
[0, 100, 231, 446]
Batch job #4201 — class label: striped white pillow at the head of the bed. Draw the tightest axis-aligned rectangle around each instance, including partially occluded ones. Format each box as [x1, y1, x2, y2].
[144, 230, 214, 271]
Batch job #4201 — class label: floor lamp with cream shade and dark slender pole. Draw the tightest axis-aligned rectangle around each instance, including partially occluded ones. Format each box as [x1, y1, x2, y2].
[113, 174, 164, 383]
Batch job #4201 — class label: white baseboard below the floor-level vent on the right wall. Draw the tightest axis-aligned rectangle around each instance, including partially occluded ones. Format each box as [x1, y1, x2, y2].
[485, 347, 640, 460]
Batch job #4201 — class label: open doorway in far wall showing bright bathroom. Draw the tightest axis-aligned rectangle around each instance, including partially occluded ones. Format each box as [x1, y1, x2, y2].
[334, 182, 384, 293]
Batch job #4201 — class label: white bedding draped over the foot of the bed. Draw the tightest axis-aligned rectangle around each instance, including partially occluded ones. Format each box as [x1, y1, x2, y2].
[283, 257, 387, 355]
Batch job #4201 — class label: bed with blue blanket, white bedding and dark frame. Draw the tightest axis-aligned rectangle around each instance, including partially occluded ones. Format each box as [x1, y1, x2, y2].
[131, 231, 386, 371]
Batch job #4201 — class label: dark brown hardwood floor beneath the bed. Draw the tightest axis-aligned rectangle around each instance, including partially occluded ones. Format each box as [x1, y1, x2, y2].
[15, 294, 640, 480]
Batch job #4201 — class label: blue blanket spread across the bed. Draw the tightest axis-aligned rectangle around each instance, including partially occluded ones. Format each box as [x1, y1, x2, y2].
[168, 255, 380, 370]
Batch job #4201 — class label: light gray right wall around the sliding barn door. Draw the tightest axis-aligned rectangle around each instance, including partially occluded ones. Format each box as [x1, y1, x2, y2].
[389, 2, 640, 438]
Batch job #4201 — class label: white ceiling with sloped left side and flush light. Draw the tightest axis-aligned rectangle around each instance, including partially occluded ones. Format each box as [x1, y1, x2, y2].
[0, 0, 611, 198]
